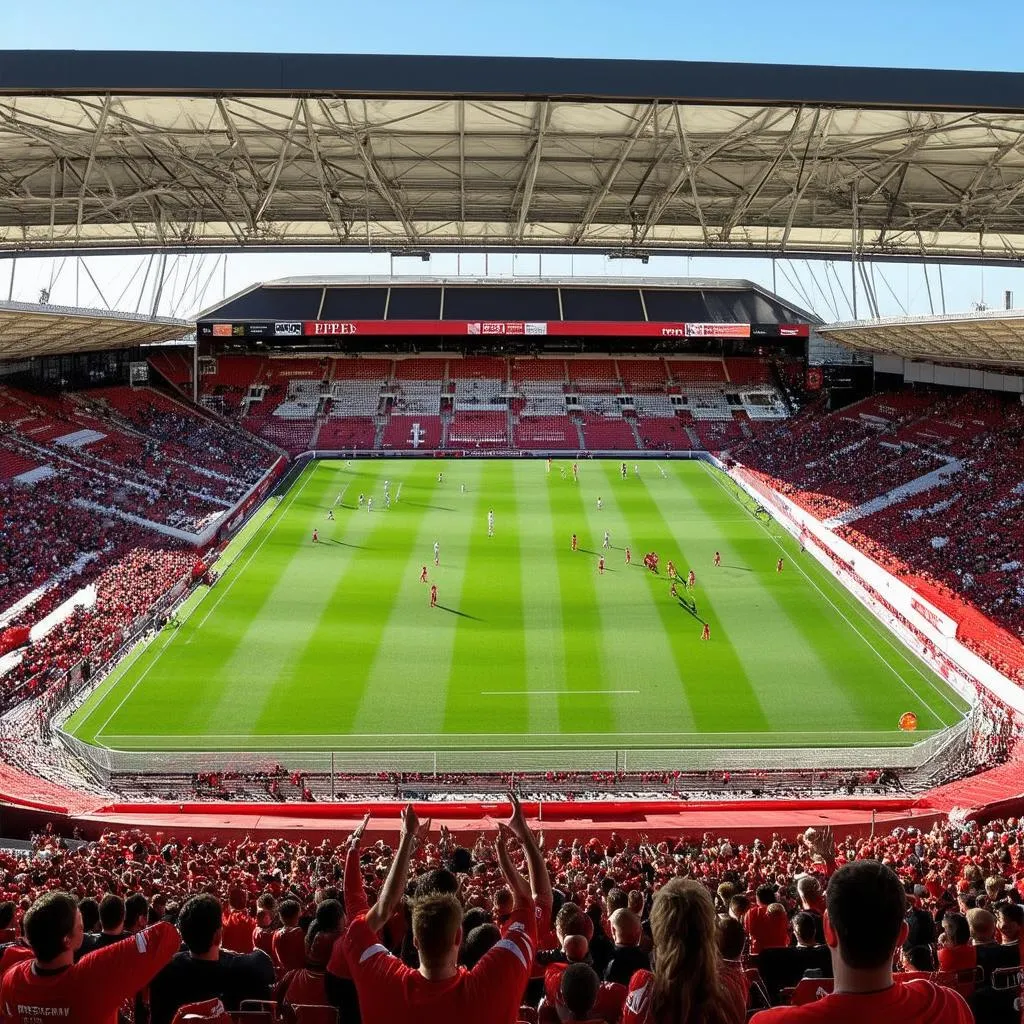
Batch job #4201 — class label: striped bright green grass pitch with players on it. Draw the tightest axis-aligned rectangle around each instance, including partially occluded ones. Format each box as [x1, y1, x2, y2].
[68, 459, 967, 752]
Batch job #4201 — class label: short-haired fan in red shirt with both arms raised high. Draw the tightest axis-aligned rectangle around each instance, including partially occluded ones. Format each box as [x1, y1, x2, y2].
[343, 797, 551, 1024]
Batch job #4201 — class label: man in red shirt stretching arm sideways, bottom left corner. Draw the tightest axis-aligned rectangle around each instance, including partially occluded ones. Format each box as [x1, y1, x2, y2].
[0, 892, 181, 1024]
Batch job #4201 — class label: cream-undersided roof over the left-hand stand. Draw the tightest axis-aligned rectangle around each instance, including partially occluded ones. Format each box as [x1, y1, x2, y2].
[0, 302, 194, 359]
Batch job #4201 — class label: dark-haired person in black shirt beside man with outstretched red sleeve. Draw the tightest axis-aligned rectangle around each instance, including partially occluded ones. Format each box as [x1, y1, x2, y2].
[150, 894, 274, 1024]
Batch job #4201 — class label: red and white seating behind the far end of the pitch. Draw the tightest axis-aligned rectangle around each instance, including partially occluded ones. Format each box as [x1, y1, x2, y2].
[188, 355, 790, 455]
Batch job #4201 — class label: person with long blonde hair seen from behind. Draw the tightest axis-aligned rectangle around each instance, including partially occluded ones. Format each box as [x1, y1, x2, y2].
[622, 879, 745, 1024]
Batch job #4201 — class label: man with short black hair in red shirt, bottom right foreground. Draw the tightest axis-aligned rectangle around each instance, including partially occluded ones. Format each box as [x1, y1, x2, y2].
[753, 860, 974, 1024]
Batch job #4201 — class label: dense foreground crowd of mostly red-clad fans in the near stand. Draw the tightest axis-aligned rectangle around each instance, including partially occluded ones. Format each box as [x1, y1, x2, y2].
[0, 806, 1024, 1024]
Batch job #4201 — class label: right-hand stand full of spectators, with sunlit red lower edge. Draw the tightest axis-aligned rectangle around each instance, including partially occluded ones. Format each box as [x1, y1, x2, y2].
[731, 389, 1024, 681]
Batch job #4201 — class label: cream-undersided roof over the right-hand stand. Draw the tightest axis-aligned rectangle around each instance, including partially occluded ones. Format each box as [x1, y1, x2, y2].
[818, 309, 1024, 366]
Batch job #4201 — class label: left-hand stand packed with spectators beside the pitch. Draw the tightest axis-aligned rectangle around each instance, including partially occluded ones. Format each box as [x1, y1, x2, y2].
[0, 387, 278, 708]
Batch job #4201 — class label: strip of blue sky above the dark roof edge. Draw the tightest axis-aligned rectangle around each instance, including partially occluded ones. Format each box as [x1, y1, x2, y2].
[8, 0, 1024, 71]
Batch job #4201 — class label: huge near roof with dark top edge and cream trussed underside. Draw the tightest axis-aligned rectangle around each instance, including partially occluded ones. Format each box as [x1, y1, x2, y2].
[6, 51, 1024, 260]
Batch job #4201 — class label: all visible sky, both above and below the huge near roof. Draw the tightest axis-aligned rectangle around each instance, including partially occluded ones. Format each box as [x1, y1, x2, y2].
[0, 0, 1024, 318]
